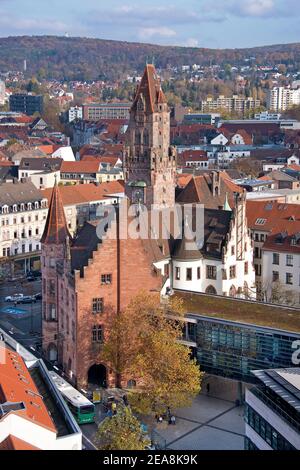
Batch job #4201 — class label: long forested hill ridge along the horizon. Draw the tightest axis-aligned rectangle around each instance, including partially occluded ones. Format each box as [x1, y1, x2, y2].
[0, 36, 300, 80]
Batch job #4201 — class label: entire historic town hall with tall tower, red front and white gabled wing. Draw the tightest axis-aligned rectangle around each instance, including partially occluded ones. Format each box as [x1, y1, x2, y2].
[41, 65, 254, 387]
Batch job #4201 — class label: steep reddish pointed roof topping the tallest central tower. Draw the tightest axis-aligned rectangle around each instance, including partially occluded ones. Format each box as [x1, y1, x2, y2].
[132, 64, 167, 114]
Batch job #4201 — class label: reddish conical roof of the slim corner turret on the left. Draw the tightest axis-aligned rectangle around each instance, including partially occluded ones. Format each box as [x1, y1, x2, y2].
[41, 179, 70, 245]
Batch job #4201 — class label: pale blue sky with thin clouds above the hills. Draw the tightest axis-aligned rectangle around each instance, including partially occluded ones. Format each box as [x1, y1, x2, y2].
[0, 0, 300, 48]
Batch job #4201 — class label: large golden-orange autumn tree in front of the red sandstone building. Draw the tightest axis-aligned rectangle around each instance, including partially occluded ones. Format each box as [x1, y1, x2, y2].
[103, 292, 202, 414]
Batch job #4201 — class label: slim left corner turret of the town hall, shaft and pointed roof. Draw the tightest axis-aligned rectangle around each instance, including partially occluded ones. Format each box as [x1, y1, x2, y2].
[41, 183, 70, 361]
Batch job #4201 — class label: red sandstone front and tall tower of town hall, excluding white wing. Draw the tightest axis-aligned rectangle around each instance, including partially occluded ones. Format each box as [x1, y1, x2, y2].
[42, 66, 171, 388]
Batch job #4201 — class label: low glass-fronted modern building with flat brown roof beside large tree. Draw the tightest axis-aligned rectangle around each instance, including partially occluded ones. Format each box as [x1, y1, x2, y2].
[175, 291, 300, 383]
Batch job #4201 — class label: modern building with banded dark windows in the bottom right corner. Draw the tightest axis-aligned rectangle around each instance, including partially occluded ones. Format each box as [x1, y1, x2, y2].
[245, 367, 300, 450]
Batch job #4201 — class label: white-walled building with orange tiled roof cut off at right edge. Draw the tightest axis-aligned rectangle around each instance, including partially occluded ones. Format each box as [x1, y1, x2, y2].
[247, 197, 300, 305]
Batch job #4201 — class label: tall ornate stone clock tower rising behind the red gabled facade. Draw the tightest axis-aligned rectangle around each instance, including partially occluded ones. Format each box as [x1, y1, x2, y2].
[124, 64, 176, 209]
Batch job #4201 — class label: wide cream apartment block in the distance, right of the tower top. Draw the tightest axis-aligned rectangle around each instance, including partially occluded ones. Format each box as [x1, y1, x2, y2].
[201, 95, 260, 114]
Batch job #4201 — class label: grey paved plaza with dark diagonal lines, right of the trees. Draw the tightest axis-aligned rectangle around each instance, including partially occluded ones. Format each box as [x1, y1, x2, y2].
[157, 395, 245, 450]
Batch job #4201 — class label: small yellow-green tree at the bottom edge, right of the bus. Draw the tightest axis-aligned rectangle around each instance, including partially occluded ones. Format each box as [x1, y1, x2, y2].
[95, 407, 150, 450]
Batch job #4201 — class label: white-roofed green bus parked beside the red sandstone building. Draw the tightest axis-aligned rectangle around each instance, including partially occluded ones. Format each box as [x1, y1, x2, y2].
[50, 371, 96, 424]
